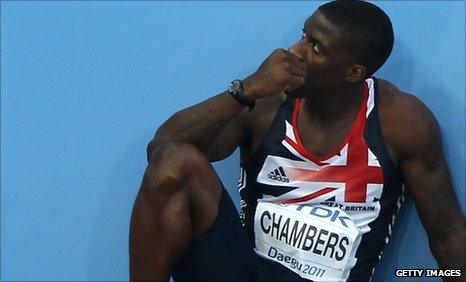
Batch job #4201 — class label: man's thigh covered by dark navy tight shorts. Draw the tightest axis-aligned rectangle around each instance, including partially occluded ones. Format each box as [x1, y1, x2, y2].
[173, 188, 254, 282]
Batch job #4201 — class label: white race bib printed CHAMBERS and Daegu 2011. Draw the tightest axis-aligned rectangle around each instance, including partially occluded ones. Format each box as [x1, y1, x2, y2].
[254, 202, 361, 281]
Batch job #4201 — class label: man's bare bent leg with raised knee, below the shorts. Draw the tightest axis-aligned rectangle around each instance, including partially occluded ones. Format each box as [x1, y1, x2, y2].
[130, 143, 222, 281]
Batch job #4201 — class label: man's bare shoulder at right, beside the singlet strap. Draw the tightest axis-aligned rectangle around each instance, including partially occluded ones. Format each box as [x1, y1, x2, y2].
[378, 79, 440, 162]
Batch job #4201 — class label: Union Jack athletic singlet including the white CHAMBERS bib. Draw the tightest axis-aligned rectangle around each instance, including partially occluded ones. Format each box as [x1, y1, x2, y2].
[239, 78, 403, 281]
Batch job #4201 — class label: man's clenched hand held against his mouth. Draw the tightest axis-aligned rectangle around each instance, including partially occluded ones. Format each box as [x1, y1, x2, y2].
[243, 49, 306, 100]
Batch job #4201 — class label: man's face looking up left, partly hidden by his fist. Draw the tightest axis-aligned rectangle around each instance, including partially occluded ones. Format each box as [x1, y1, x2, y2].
[287, 11, 351, 98]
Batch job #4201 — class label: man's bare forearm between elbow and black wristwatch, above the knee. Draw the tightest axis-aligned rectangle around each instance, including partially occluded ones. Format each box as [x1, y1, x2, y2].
[148, 92, 244, 155]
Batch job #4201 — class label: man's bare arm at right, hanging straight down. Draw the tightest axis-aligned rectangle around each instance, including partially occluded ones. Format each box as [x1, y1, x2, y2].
[391, 95, 466, 277]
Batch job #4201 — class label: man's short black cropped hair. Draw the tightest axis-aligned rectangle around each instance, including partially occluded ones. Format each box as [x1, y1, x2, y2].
[318, 0, 394, 76]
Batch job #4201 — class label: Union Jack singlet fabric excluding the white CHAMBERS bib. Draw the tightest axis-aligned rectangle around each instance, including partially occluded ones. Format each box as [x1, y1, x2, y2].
[240, 78, 402, 280]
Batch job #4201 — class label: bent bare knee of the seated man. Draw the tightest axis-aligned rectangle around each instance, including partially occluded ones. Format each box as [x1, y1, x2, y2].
[144, 142, 209, 192]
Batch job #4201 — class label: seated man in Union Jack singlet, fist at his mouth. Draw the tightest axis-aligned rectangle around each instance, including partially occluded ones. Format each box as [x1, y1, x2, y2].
[130, 1, 465, 281]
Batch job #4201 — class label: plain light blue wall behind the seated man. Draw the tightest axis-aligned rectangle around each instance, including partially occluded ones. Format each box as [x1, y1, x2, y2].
[1, 1, 465, 281]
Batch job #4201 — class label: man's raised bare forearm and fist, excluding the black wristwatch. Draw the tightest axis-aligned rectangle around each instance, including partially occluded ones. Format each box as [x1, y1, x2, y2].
[147, 49, 306, 161]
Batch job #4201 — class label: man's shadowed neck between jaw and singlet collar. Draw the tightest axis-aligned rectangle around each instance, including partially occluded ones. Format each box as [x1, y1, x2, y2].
[301, 82, 364, 123]
